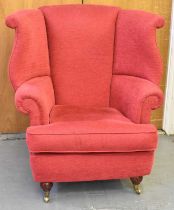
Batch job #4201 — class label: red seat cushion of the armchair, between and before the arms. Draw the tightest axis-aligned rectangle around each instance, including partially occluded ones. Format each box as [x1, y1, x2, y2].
[27, 105, 157, 153]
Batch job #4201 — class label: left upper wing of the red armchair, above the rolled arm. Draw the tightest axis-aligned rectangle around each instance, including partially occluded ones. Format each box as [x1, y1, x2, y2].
[6, 10, 50, 89]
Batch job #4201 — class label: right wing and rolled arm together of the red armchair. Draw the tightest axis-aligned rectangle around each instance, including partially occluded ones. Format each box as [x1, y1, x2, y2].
[110, 10, 164, 123]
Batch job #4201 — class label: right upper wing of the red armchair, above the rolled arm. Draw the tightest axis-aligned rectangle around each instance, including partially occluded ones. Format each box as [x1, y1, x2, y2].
[113, 10, 164, 84]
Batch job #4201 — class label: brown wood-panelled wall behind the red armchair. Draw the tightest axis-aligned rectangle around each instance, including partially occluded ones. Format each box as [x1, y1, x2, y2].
[0, 0, 172, 133]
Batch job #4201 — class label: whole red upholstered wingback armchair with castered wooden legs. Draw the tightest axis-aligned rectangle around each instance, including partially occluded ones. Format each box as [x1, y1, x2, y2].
[6, 5, 164, 202]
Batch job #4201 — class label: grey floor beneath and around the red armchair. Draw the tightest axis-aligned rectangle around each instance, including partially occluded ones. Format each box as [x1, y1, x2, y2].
[0, 135, 174, 210]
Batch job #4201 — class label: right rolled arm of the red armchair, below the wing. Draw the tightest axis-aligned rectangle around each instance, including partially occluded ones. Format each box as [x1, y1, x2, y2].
[110, 75, 163, 123]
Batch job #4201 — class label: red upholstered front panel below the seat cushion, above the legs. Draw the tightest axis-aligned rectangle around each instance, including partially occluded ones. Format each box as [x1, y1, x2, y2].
[30, 151, 154, 182]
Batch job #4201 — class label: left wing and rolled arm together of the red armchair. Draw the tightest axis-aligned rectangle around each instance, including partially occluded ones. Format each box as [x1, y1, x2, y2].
[6, 10, 55, 125]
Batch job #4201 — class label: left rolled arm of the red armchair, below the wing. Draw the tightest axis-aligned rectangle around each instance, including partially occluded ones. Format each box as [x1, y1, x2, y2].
[15, 76, 55, 125]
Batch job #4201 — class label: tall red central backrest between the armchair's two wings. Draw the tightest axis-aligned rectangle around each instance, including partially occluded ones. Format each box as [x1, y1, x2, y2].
[41, 5, 118, 106]
